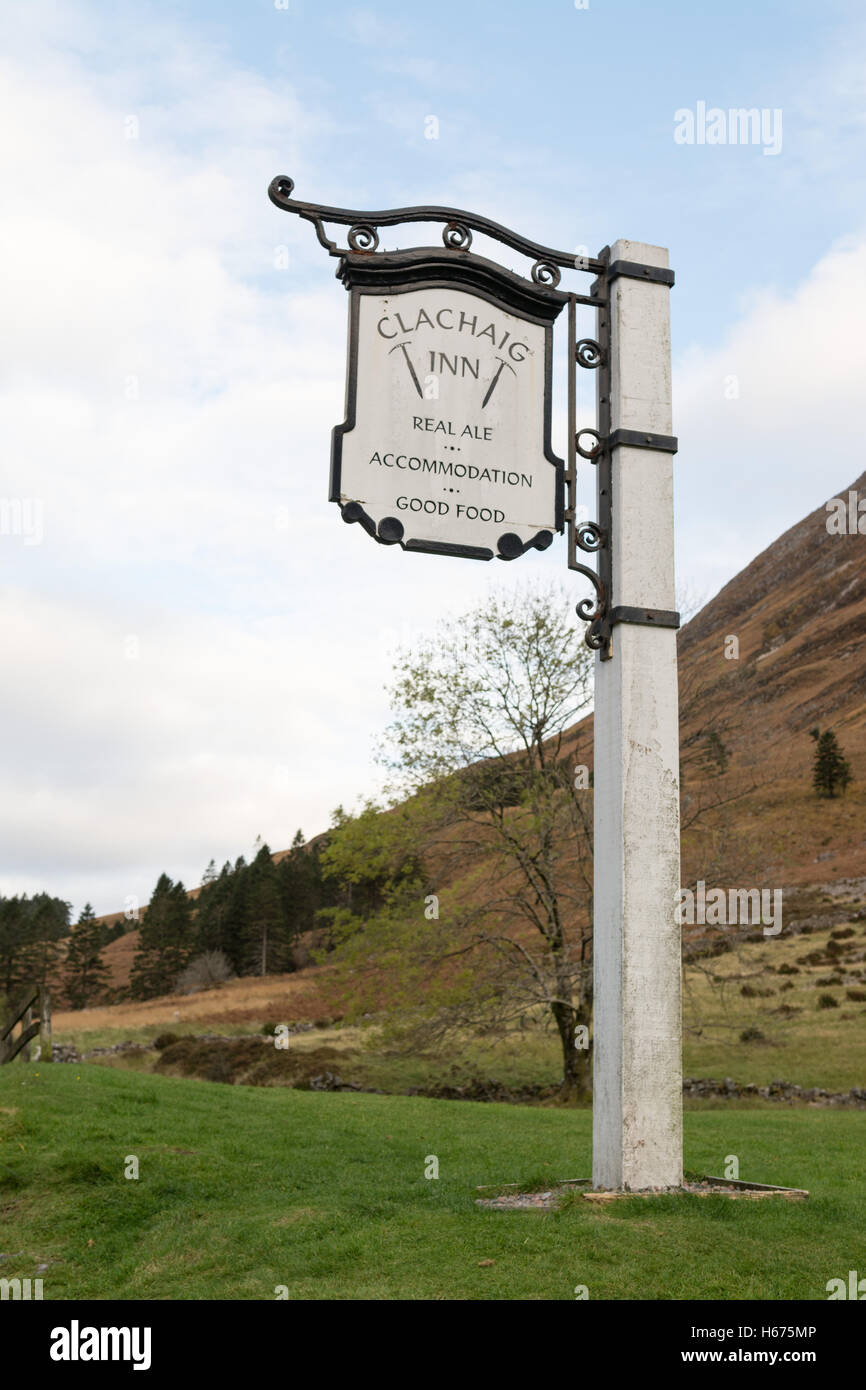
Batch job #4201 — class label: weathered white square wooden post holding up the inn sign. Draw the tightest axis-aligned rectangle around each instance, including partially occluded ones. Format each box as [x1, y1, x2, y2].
[592, 240, 683, 1191]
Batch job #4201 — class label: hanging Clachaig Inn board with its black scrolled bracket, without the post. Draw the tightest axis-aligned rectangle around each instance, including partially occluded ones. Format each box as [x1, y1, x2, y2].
[268, 175, 678, 657]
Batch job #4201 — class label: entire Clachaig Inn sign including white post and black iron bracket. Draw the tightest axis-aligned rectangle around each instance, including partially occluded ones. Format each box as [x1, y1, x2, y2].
[268, 177, 683, 1190]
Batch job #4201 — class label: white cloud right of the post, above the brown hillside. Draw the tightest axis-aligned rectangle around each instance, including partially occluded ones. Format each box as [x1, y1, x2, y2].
[674, 229, 866, 592]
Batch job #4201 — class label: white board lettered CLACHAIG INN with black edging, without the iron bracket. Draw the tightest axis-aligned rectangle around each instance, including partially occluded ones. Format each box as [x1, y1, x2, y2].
[331, 285, 562, 559]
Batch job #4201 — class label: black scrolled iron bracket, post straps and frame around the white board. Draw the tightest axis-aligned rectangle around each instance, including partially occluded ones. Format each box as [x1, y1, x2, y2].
[268, 175, 680, 660]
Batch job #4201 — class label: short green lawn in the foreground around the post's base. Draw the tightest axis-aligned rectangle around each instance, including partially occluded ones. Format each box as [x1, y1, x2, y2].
[0, 1065, 866, 1300]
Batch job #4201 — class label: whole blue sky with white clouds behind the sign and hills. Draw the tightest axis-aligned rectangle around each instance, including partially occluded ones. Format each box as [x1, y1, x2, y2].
[0, 0, 866, 913]
